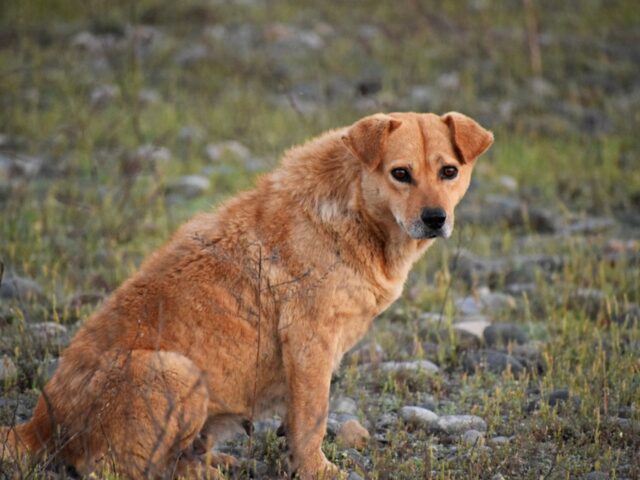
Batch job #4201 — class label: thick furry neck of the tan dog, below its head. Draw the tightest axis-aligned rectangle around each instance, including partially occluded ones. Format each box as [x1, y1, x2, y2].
[270, 130, 433, 290]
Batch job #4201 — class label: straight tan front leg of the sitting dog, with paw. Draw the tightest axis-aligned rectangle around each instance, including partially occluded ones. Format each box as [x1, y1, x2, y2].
[282, 326, 339, 480]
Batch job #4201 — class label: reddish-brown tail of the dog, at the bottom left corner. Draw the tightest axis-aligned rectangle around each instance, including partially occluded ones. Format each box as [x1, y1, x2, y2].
[0, 402, 53, 463]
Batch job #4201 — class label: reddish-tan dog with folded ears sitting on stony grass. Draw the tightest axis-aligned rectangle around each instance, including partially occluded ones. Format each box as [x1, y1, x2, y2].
[0, 112, 493, 479]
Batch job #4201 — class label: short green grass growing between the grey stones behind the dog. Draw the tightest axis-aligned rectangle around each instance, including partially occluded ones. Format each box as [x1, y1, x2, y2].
[0, 0, 640, 479]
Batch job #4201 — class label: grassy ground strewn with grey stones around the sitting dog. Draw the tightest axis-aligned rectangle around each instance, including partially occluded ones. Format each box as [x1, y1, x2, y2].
[0, 0, 640, 480]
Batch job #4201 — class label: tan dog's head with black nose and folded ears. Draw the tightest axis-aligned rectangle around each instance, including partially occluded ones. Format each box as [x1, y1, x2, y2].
[342, 112, 493, 239]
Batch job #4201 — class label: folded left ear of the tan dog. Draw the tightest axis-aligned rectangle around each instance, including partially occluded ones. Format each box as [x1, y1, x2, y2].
[342, 113, 402, 171]
